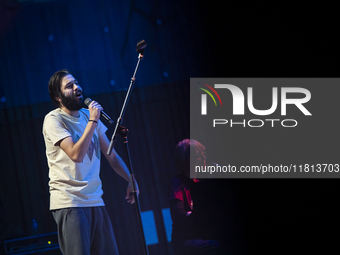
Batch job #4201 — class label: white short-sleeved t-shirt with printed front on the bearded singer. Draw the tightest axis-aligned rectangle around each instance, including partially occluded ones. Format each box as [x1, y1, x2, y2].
[43, 108, 107, 210]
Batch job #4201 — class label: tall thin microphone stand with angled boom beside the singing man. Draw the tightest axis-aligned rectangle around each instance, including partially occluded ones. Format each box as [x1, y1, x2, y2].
[107, 40, 149, 255]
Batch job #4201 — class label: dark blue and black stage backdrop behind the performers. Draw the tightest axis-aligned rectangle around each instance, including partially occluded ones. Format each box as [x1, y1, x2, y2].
[0, 0, 340, 254]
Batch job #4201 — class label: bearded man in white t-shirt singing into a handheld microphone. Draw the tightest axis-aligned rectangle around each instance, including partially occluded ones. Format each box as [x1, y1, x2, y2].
[43, 70, 137, 255]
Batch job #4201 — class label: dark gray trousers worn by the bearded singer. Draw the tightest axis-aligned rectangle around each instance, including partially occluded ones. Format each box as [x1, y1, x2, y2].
[52, 206, 119, 255]
